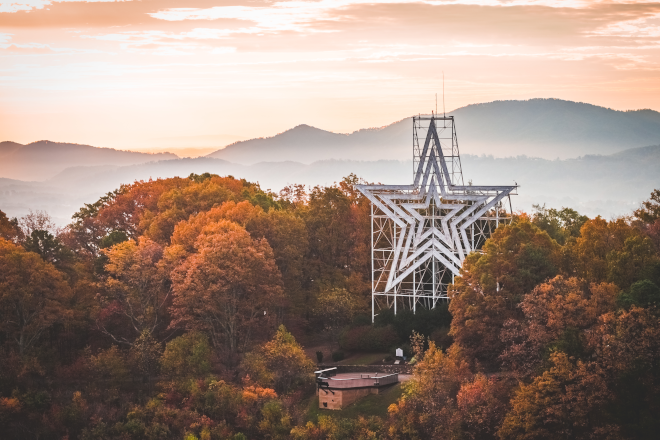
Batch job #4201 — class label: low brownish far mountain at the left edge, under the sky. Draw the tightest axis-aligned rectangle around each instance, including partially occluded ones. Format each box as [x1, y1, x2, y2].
[0, 141, 178, 180]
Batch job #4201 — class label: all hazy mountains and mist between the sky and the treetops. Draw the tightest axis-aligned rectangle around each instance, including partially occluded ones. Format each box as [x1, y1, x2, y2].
[0, 99, 660, 224]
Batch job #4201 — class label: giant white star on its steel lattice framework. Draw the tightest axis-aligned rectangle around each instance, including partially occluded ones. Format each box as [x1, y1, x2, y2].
[356, 115, 517, 320]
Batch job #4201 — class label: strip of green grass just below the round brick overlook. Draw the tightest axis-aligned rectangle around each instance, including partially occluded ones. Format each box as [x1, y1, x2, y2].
[306, 383, 403, 423]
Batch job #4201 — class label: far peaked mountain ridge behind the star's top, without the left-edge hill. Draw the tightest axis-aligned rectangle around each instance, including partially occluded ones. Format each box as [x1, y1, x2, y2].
[208, 99, 660, 165]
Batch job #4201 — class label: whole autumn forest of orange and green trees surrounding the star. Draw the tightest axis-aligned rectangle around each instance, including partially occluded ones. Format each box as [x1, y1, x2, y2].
[0, 173, 660, 440]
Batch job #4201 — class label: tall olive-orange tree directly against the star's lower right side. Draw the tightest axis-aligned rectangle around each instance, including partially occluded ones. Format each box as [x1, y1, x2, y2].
[449, 216, 560, 369]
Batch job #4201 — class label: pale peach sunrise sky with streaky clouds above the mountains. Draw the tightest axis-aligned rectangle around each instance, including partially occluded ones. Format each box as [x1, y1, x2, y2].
[0, 0, 660, 150]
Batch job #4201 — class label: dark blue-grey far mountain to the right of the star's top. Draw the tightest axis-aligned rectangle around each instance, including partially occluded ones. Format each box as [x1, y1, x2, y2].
[452, 99, 660, 159]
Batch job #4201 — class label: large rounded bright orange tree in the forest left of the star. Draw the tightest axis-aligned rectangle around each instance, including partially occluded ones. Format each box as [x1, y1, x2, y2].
[172, 220, 283, 352]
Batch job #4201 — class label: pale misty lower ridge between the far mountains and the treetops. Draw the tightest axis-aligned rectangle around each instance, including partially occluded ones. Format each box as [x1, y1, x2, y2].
[0, 145, 660, 224]
